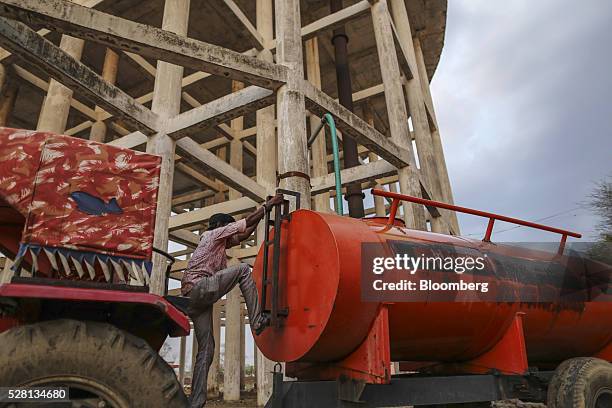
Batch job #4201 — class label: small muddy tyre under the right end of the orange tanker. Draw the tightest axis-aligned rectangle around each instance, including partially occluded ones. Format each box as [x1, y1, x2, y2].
[547, 357, 612, 408]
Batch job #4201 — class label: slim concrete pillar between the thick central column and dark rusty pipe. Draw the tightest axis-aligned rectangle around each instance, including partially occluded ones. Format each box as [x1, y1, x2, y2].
[305, 37, 332, 212]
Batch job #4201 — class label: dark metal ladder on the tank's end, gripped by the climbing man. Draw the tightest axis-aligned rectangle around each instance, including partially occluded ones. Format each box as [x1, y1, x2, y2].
[261, 188, 300, 328]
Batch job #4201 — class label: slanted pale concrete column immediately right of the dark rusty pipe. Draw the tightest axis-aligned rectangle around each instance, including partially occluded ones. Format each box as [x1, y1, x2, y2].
[372, 0, 426, 230]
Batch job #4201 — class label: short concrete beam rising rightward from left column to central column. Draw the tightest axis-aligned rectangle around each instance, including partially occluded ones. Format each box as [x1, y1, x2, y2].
[167, 86, 275, 140]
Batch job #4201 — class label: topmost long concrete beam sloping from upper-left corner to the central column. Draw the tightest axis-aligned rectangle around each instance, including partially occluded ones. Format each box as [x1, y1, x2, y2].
[0, 0, 287, 89]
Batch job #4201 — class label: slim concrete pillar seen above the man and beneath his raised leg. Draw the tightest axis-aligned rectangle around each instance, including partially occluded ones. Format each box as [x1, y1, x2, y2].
[223, 81, 244, 401]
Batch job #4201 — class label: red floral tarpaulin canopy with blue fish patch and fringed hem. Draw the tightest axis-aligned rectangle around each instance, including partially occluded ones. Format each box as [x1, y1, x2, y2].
[0, 128, 161, 280]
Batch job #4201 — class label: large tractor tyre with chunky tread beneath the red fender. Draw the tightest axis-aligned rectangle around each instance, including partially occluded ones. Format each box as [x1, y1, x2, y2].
[0, 320, 187, 408]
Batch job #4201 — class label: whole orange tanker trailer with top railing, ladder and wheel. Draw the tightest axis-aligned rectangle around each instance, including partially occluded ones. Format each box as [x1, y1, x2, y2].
[254, 190, 612, 408]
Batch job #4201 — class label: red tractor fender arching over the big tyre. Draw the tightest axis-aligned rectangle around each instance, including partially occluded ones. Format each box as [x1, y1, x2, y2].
[0, 284, 190, 350]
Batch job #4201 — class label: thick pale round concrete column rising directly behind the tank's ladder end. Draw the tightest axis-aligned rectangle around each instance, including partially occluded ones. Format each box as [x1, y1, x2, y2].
[275, 0, 310, 208]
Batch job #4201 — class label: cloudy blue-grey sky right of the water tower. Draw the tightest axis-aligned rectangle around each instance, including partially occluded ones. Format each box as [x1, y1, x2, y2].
[431, 0, 612, 241]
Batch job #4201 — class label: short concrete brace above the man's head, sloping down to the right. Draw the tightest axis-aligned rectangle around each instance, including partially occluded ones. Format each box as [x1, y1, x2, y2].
[176, 137, 267, 202]
